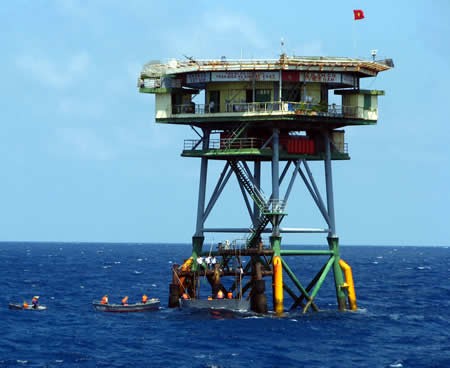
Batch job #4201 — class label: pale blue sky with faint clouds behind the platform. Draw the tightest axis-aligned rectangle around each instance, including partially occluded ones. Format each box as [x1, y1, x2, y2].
[0, 0, 450, 245]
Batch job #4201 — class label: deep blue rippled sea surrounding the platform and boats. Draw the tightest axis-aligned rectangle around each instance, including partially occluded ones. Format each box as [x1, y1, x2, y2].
[0, 242, 450, 368]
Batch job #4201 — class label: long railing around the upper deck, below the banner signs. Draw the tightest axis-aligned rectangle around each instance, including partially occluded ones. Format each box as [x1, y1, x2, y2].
[172, 101, 378, 120]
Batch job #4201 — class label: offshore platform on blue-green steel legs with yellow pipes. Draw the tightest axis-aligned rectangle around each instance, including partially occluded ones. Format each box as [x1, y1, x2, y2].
[138, 54, 393, 314]
